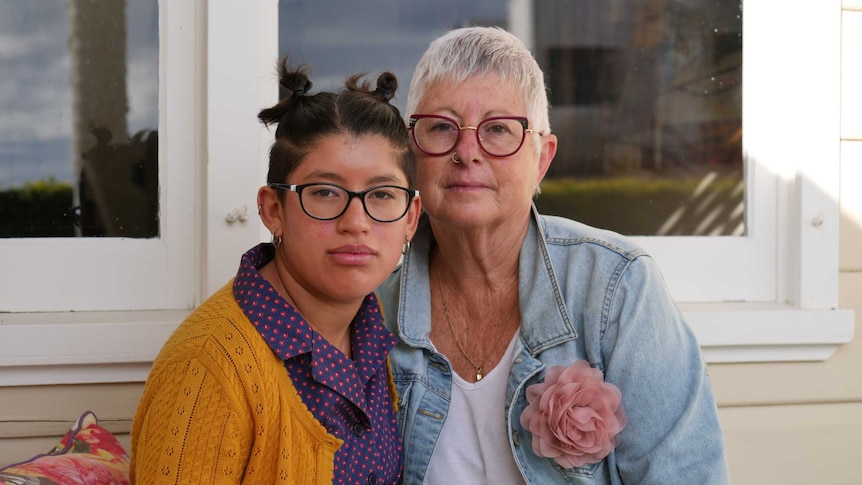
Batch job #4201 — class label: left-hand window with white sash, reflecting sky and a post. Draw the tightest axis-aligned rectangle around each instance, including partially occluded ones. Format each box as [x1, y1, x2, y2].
[0, 0, 195, 312]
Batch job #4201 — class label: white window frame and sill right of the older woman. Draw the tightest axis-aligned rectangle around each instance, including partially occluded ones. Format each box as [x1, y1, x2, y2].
[640, 0, 854, 362]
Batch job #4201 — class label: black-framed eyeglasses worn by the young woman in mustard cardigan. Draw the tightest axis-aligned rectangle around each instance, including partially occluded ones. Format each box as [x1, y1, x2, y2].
[269, 183, 419, 222]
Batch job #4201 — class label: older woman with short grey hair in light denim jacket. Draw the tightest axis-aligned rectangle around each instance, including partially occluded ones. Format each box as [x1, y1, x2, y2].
[379, 27, 729, 485]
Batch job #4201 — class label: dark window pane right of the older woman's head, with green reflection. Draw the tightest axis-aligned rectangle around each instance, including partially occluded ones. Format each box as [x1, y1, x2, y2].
[535, 0, 745, 236]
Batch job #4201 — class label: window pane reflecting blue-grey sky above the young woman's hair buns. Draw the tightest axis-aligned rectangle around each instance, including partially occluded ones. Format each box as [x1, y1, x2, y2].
[280, 0, 510, 117]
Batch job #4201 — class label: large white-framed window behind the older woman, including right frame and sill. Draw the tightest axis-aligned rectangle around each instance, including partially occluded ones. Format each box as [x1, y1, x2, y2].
[279, 0, 852, 361]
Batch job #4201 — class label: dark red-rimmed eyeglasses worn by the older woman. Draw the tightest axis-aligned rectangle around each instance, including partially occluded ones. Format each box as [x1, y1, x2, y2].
[410, 114, 538, 157]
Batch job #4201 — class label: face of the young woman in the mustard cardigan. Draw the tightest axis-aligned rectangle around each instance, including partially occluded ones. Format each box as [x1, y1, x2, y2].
[278, 135, 420, 302]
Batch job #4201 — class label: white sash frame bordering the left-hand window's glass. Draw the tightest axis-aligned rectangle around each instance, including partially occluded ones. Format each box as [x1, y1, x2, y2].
[0, 0, 195, 312]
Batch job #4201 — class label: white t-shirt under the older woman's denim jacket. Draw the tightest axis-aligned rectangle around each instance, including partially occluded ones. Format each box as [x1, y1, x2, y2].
[425, 332, 524, 485]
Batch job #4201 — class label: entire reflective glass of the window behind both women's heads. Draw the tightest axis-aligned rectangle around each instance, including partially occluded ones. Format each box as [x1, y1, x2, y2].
[279, 0, 745, 236]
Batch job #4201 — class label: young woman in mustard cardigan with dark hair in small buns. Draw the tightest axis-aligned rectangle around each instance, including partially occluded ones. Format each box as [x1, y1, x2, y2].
[131, 59, 420, 485]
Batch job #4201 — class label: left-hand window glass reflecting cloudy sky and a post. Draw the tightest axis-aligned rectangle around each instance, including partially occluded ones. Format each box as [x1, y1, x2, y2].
[0, 0, 159, 238]
